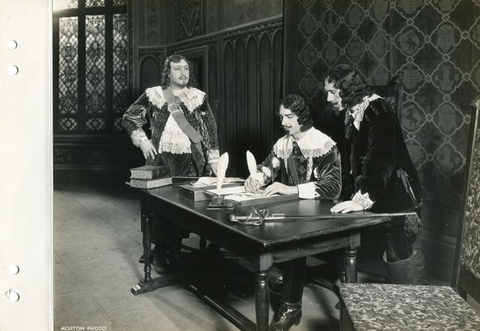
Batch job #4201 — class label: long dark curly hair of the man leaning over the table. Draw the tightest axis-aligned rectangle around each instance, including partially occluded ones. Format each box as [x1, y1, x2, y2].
[327, 64, 373, 108]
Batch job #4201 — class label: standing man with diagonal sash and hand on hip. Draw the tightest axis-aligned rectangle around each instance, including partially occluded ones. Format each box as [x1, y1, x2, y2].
[122, 55, 220, 273]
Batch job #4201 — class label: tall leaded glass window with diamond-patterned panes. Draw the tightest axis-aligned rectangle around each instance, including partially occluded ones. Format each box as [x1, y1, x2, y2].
[54, 0, 128, 134]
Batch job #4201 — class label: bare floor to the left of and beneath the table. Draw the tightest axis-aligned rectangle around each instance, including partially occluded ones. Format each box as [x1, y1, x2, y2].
[53, 185, 390, 331]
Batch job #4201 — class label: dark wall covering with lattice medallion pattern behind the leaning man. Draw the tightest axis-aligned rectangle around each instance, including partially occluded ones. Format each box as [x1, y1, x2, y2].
[285, 0, 480, 236]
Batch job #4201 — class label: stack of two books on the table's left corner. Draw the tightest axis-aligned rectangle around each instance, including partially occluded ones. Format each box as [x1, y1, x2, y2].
[128, 165, 172, 189]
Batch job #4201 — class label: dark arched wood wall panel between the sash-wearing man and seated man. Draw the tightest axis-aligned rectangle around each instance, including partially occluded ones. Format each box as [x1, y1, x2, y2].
[219, 21, 283, 176]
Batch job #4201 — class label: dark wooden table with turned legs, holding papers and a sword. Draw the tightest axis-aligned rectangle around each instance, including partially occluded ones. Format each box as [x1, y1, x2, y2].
[131, 184, 389, 330]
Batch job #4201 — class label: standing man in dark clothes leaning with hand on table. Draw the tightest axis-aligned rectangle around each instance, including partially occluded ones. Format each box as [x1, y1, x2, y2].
[324, 65, 426, 284]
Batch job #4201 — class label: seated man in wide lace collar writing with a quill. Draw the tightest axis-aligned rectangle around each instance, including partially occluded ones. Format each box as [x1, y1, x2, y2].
[245, 94, 342, 330]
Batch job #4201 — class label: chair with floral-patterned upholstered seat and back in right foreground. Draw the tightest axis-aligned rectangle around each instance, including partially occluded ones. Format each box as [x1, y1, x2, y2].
[340, 97, 480, 331]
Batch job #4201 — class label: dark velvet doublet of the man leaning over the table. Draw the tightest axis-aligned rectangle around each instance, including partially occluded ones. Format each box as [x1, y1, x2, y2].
[343, 98, 421, 212]
